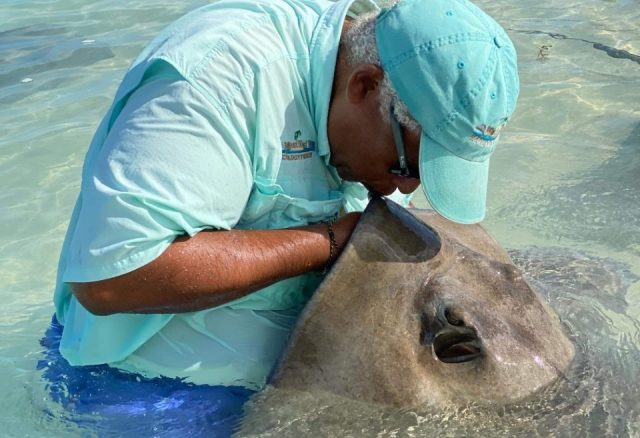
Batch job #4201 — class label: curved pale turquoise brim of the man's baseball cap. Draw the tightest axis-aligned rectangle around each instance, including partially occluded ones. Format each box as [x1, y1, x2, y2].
[420, 133, 489, 224]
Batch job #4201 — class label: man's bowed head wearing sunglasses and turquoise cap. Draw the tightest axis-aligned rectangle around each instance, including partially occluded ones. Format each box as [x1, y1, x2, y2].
[329, 0, 518, 223]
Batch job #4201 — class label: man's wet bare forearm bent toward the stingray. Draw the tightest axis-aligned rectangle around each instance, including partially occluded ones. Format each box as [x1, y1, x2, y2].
[71, 215, 359, 315]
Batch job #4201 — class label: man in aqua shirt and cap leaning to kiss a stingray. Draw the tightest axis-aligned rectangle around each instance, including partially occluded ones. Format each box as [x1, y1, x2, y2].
[55, 0, 518, 388]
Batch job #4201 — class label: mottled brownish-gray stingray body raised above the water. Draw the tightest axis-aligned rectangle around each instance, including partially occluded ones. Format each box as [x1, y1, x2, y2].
[272, 198, 574, 407]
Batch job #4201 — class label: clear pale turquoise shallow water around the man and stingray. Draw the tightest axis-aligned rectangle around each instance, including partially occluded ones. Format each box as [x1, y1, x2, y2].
[0, 0, 640, 436]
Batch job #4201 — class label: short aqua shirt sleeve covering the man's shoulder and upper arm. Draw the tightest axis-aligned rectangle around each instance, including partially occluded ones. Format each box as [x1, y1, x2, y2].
[63, 78, 253, 282]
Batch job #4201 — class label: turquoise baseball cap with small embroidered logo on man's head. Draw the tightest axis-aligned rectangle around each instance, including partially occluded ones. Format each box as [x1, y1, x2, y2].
[376, 0, 519, 223]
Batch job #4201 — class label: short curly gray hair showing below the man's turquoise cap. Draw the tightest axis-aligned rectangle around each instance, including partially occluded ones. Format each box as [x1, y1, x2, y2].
[342, 12, 420, 130]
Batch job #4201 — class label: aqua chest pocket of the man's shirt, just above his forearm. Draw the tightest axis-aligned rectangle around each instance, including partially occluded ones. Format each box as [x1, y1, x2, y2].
[237, 178, 344, 229]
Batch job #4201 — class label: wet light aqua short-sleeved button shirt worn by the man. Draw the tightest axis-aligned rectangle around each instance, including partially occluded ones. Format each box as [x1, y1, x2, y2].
[54, 0, 376, 388]
